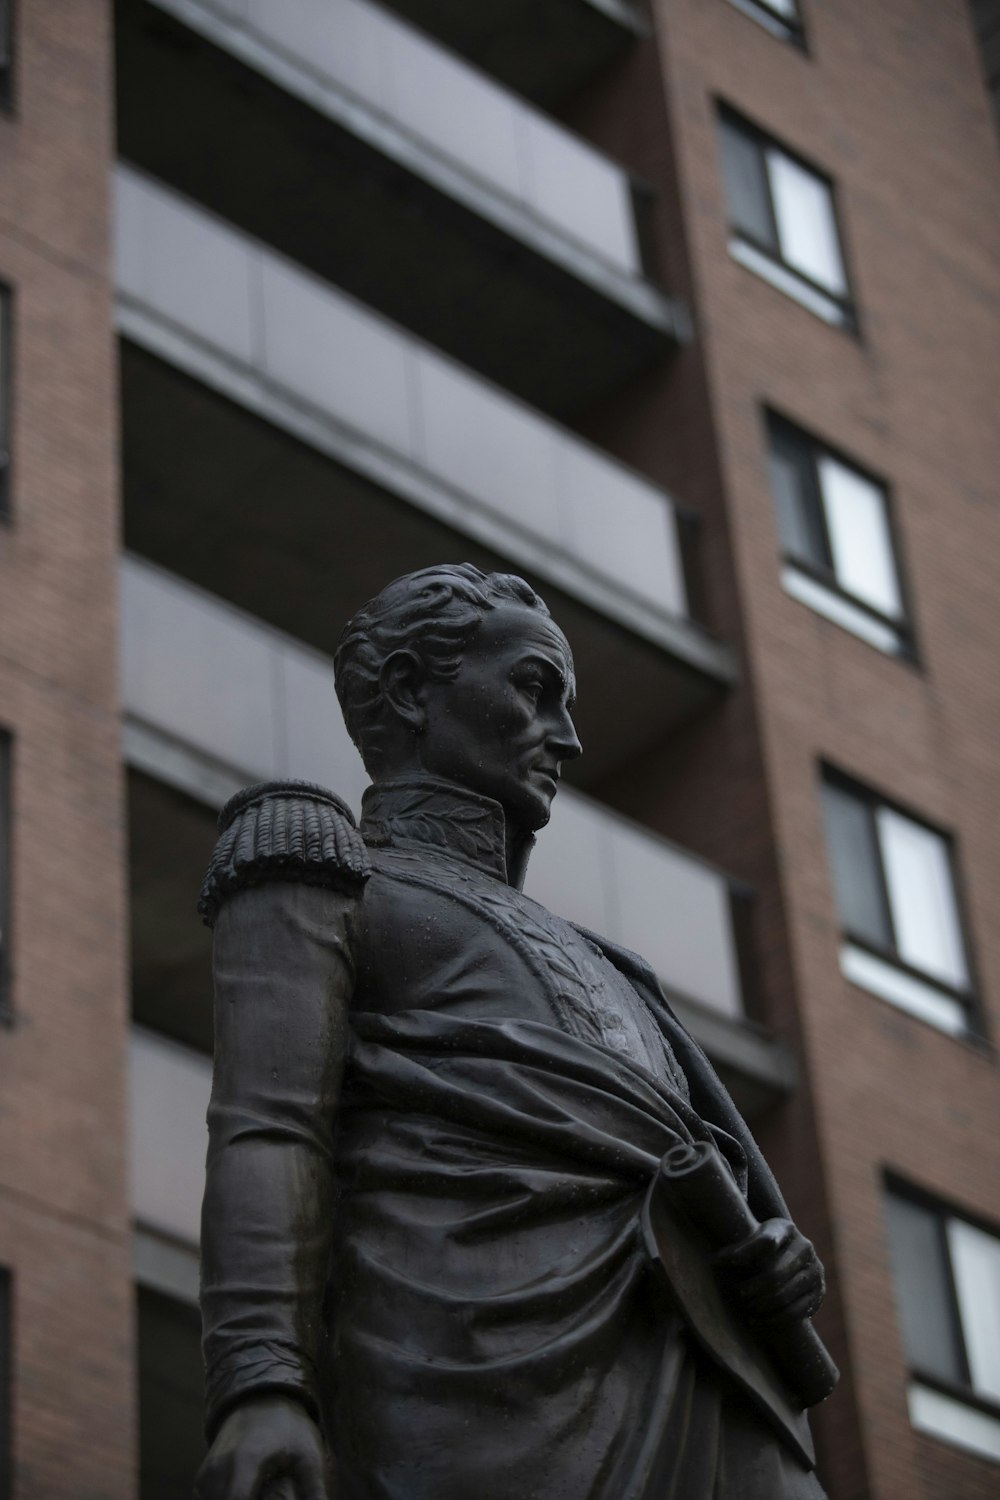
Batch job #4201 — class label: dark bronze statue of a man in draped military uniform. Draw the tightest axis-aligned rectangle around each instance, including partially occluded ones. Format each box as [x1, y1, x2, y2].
[196, 566, 823, 1500]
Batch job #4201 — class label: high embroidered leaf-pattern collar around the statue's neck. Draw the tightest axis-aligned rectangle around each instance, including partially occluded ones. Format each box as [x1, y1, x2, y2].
[361, 777, 535, 890]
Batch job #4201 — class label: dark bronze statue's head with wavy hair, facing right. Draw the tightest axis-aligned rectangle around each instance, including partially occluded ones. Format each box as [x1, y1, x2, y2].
[334, 563, 580, 830]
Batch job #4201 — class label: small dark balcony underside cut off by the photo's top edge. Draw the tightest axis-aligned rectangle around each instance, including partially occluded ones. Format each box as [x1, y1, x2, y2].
[377, 0, 645, 105]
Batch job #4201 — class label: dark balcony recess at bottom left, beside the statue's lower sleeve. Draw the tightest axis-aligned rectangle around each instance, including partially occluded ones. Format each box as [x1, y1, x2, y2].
[138, 1287, 205, 1500]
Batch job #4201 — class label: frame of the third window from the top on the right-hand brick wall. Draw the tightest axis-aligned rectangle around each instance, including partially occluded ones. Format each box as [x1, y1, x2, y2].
[765, 411, 916, 660]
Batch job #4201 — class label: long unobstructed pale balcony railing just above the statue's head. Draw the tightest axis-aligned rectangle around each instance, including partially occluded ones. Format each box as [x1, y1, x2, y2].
[115, 167, 732, 720]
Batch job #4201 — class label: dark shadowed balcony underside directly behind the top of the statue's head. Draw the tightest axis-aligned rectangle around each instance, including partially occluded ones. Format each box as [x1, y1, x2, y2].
[121, 344, 726, 788]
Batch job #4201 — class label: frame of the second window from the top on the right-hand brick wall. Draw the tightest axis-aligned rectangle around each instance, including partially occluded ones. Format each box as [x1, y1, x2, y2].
[718, 105, 858, 330]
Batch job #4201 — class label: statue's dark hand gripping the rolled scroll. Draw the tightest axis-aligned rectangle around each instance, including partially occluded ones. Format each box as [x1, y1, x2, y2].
[715, 1218, 826, 1323]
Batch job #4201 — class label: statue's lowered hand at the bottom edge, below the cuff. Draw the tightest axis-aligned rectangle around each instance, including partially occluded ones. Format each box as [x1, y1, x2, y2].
[193, 1395, 333, 1500]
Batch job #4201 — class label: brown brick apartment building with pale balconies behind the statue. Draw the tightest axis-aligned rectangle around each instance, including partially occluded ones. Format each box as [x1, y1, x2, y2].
[0, 0, 1000, 1500]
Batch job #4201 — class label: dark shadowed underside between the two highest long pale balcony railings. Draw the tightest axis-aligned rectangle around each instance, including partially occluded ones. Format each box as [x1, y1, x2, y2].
[117, 3, 678, 417]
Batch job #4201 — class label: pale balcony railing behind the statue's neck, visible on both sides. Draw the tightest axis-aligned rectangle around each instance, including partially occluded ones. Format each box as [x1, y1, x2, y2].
[121, 558, 742, 1020]
